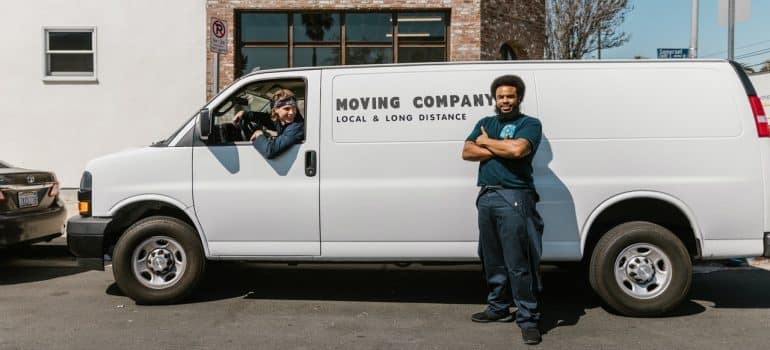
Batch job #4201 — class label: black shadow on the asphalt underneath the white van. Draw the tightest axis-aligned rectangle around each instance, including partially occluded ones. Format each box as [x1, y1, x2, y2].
[107, 262, 770, 332]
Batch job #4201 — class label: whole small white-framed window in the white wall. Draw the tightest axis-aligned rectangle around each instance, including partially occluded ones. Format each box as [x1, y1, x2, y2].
[44, 28, 96, 80]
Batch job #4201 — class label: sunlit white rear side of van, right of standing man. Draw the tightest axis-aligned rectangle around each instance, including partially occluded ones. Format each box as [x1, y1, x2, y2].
[536, 62, 764, 258]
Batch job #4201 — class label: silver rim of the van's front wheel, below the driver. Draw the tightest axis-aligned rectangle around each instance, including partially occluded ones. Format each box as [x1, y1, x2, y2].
[131, 236, 187, 289]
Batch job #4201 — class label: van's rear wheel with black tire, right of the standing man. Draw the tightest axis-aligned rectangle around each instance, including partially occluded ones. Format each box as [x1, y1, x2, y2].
[589, 221, 692, 317]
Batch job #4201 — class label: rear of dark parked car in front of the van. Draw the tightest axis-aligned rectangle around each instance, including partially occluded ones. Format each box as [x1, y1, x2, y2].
[0, 161, 67, 247]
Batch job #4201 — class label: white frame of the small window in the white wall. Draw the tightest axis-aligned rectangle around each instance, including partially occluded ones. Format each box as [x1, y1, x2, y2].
[42, 26, 98, 82]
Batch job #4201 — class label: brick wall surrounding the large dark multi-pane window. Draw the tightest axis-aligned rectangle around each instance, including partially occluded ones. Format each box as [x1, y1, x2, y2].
[206, 0, 543, 96]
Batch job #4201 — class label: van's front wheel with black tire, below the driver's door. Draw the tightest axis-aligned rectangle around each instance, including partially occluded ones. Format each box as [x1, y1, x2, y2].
[112, 216, 206, 304]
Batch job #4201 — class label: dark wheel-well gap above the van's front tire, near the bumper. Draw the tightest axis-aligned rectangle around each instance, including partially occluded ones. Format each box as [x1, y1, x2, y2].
[102, 201, 195, 256]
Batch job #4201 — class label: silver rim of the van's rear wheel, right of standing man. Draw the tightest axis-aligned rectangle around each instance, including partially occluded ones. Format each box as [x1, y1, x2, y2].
[615, 243, 673, 299]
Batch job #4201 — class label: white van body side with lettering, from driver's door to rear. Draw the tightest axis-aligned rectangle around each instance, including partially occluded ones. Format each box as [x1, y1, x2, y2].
[319, 61, 764, 261]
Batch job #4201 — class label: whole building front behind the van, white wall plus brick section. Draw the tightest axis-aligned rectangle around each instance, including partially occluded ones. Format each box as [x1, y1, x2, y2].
[0, 0, 544, 188]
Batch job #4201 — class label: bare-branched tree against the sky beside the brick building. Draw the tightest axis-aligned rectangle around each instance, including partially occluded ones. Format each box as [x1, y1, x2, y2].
[543, 0, 633, 59]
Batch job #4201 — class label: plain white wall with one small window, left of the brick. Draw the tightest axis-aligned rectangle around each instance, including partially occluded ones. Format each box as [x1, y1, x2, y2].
[0, 0, 207, 188]
